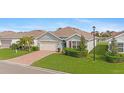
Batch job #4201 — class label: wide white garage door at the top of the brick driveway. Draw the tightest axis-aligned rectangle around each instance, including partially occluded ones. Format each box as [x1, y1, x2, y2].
[40, 41, 58, 51]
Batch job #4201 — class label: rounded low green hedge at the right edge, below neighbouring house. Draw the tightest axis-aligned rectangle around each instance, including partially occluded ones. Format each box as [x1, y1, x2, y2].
[105, 52, 124, 63]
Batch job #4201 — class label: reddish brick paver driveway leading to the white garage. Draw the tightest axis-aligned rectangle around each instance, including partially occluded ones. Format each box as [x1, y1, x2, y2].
[8, 50, 55, 65]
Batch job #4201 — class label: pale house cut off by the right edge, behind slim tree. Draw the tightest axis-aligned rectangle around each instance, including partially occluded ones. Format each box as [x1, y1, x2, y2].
[108, 32, 124, 53]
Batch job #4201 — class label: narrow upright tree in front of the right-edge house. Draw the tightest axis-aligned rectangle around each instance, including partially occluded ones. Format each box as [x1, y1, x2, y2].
[110, 38, 118, 55]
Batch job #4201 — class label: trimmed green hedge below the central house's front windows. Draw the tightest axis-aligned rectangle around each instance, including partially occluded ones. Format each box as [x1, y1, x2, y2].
[64, 48, 88, 57]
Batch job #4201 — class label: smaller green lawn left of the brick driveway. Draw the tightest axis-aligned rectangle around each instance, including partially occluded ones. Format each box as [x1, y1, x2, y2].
[0, 48, 29, 60]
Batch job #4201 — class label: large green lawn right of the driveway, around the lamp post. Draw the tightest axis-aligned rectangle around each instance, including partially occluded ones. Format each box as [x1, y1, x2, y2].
[32, 43, 124, 74]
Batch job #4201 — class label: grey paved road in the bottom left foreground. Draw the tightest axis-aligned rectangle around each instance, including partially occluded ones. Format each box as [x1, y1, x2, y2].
[0, 61, 64, 74]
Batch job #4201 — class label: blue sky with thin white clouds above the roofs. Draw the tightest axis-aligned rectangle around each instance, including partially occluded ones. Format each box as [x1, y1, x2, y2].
[0, 18, 124, 32]
